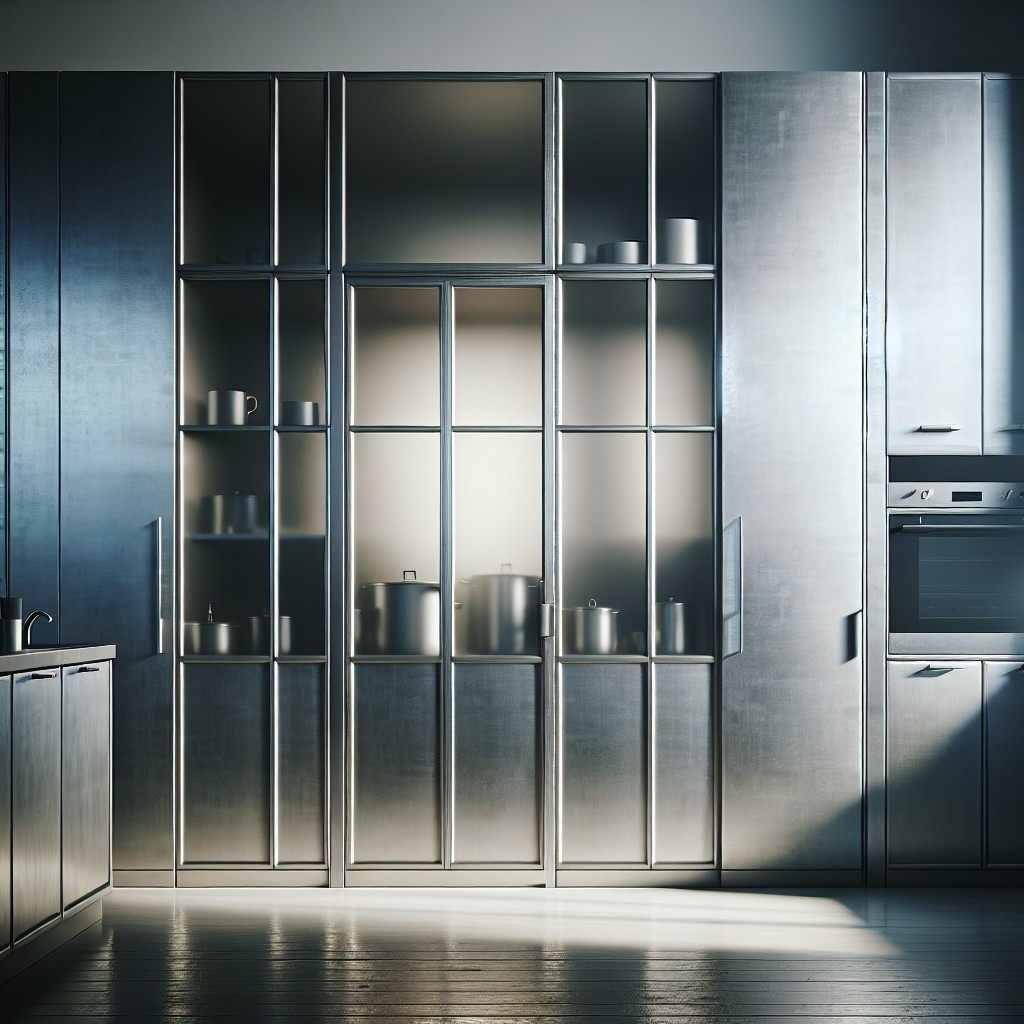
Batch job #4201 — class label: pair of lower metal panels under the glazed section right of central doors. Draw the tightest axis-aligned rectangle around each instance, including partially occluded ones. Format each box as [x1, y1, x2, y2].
[558, 663, 715, 884]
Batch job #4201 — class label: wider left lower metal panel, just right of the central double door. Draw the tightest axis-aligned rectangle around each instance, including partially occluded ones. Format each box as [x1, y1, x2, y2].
[558, 665, 648, 867]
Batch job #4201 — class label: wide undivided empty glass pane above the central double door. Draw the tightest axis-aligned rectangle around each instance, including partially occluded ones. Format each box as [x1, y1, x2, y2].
[345, 76, 546, 264]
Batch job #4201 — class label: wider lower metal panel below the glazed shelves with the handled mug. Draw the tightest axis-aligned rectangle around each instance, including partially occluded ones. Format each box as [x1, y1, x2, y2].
[179, 665, 271, 866]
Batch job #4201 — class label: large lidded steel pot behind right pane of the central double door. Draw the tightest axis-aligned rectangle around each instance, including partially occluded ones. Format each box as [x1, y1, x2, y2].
[462, 562, 541, 654]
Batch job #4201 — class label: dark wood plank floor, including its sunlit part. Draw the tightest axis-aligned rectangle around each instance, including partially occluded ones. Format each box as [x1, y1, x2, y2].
[0, 889, 1024, 1024]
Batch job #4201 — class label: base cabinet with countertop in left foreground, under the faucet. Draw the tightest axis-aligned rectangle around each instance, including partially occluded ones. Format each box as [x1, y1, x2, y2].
[0, 646, 114, 982]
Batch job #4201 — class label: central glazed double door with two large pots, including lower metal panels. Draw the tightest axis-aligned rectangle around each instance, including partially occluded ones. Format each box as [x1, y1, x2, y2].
[346, 279, 550, 884]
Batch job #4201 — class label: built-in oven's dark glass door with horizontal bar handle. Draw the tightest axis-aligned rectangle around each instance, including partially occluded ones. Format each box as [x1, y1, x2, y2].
[889, 511, 1024, 656]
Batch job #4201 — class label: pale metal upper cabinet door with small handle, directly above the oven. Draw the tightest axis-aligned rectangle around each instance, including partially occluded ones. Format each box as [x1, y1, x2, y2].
[886, 75, 982, 455]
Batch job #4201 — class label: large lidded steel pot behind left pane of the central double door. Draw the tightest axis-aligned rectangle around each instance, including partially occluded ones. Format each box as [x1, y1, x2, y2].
[359, 569, 441, 657]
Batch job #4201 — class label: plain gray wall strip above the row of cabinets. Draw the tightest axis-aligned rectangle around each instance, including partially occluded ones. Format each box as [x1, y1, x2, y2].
[0, 0, 1024, 72]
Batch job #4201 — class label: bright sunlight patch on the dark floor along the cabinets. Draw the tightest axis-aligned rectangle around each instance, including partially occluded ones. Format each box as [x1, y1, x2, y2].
[105, 888, 899, 957]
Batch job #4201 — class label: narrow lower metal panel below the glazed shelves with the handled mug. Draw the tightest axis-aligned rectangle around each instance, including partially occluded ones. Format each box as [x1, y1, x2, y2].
[276, 665, 327, 864]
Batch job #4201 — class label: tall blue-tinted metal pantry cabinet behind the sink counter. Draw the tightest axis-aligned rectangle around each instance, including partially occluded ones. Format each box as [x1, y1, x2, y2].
[5, 72, 175, 885]
